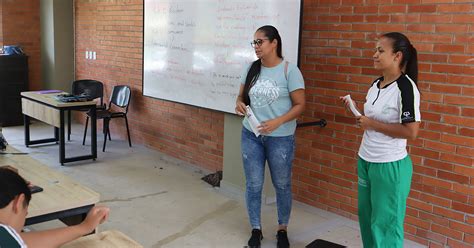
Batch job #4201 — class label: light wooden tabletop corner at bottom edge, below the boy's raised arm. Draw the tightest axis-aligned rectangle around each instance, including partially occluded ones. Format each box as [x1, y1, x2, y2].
[61, 230, 143, 248]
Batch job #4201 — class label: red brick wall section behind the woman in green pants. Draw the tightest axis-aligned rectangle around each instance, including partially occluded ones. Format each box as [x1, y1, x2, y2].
[293, 0, 474, 247]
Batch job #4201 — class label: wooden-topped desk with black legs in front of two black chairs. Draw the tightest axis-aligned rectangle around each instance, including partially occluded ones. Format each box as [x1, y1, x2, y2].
[21, 91, 97, 165]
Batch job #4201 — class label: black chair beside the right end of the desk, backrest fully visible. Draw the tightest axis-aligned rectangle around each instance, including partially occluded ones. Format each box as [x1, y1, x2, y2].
[82, 85, 132, 152]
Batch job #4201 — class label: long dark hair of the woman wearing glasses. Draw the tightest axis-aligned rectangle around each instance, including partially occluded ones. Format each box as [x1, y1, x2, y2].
[242, 25, 283, 105]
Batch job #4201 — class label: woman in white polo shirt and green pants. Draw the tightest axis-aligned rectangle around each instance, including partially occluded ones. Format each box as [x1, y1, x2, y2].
[341, 32, 421, 248]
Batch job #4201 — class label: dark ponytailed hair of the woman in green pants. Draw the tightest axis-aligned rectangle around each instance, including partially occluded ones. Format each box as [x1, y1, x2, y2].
[381, 32, 418, 86]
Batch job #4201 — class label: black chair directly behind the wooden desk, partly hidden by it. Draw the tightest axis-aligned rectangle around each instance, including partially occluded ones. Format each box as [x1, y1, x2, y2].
[67, 79, 105, 140]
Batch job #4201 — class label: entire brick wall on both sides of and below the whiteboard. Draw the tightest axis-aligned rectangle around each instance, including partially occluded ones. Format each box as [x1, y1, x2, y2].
[75, 0, 474, 247]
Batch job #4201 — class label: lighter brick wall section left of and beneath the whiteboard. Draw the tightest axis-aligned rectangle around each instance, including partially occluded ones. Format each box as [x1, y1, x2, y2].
[75, 0, 224, 171]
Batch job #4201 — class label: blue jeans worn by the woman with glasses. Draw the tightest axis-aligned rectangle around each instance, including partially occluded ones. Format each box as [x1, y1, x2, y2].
[241, 127, 295, 229]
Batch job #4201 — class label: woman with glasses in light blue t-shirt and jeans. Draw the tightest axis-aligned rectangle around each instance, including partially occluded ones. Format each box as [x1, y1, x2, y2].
[235, 26, 305, 248]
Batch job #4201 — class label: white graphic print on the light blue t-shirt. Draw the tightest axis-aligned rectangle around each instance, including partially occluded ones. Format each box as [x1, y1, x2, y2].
[249, 76, 280, 108]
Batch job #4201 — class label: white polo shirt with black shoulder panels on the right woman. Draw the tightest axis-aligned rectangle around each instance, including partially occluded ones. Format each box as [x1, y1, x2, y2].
[359, 74, 421, 163]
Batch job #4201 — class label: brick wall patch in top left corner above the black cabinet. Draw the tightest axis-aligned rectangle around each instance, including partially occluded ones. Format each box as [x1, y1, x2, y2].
[2, 0, 42, 90]
